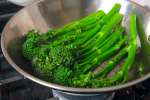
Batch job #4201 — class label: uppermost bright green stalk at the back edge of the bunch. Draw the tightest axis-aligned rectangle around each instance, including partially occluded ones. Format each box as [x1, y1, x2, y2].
[42, 10, 105, 42]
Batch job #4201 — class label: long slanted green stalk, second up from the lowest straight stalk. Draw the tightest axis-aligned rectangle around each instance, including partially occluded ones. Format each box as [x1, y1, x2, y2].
[79, 36, 127, 73]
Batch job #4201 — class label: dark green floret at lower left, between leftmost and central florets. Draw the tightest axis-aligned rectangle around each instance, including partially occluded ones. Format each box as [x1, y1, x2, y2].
[32, 48, 55, 81]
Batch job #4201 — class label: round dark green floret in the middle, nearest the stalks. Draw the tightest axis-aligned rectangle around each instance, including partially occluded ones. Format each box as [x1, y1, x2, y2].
[49, 45, 75, 67]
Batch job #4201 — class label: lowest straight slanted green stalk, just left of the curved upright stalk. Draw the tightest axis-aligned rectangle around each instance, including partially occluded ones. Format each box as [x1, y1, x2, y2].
[95, 47, 128, 78]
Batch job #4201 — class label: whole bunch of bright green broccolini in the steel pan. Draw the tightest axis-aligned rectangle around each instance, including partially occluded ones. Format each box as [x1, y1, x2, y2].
[22, 4, 137, 87]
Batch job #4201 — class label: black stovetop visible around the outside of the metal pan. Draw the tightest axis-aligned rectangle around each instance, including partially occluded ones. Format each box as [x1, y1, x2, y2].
[0, 0, 150, 100]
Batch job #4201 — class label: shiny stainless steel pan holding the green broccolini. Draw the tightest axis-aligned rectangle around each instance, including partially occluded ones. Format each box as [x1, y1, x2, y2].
[1, 0, 150, 93]
